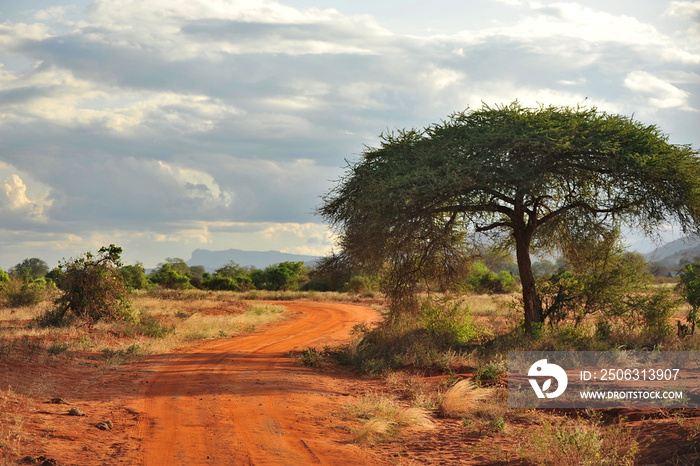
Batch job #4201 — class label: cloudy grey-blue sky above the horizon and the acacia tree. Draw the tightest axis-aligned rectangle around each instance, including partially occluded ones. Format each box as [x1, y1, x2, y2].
[0, 0, 700, 268]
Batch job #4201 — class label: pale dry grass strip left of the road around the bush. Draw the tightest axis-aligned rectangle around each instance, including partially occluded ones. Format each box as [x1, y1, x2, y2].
[0, 292, 284, 365]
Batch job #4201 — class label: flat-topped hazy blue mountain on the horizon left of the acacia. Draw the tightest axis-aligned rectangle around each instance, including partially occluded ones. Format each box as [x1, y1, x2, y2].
[187, 249, 321, 272]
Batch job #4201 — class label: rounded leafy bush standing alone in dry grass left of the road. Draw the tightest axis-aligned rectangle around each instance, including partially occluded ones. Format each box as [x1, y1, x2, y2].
[49, 244, 131, 324]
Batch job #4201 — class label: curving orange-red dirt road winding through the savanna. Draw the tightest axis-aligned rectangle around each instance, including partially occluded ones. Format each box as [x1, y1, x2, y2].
[131, 302, 378, 466]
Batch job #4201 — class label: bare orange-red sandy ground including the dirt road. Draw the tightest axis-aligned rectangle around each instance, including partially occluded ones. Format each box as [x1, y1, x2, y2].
[0, 302, 700, 466]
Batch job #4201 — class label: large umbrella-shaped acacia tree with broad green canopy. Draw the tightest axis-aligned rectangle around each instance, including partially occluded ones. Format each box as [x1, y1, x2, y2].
[318, 102, 700, 331]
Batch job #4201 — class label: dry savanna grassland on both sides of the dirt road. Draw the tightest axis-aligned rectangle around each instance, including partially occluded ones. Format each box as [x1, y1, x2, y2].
[0, 290, 700, 465]
